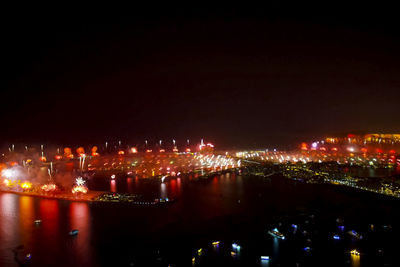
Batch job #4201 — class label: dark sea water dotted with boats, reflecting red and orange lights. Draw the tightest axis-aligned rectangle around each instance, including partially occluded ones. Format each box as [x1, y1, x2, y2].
[0, 173, 400, 266]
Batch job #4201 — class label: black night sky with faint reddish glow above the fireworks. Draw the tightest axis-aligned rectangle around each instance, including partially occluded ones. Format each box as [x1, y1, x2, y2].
[0, 3, 400, 150]
